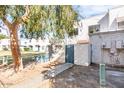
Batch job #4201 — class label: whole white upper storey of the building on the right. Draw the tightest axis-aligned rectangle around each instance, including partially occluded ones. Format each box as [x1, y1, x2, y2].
[77, 6, 124, 40]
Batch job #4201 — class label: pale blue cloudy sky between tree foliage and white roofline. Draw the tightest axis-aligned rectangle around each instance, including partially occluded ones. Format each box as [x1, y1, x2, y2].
[74, 5, 115, 18]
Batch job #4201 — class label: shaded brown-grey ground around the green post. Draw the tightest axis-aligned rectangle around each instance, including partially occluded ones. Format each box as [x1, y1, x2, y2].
[51, 65, 124, 88]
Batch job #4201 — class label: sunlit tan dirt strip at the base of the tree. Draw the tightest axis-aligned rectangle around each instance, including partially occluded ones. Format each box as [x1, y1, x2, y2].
[0, 62, 61, 87]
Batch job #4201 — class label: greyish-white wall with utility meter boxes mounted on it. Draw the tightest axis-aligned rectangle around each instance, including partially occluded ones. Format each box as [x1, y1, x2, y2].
[90, 31, 124, 65]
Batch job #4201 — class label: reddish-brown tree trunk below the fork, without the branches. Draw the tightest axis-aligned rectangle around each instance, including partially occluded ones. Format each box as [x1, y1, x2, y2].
[10, 25, 23, 72]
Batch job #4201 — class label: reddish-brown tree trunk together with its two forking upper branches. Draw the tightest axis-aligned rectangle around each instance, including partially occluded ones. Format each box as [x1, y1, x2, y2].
[2, 6, 29, 72]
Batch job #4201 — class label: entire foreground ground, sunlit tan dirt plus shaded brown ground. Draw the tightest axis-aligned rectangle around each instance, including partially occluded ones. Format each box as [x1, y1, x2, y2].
[0, 63, 124, 88]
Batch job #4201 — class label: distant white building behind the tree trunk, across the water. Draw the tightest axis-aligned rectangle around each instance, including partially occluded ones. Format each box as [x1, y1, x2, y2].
[0, 39, 49, 52]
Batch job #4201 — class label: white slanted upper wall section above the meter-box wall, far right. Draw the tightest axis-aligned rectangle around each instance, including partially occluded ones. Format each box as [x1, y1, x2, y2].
[99, 6, 124, 32]
